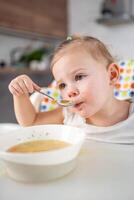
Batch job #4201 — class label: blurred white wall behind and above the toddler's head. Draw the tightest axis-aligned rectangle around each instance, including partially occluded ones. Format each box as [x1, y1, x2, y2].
[68, 0, 134, 59]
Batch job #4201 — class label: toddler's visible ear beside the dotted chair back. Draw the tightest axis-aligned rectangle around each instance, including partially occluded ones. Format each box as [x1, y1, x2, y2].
[108, 63, 119, 85]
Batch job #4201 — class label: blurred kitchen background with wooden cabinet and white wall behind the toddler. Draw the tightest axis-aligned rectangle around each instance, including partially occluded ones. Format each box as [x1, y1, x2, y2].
[0, 0, 134, 123]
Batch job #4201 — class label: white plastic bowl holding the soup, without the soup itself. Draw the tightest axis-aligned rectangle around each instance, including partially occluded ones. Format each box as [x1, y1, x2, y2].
[0, 125, 85, 182]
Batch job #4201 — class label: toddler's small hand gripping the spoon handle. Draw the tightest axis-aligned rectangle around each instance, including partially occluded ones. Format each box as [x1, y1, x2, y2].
[8, 75, 41, 96]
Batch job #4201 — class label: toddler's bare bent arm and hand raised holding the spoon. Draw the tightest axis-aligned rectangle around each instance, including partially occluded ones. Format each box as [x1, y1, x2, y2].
[9, 75, 63, 126]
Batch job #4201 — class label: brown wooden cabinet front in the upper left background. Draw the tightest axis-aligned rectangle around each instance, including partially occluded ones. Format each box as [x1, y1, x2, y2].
[0, 0, 67, 37]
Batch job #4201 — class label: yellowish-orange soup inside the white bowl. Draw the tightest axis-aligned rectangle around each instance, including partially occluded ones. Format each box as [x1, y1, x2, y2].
[7, 140, 71, 153]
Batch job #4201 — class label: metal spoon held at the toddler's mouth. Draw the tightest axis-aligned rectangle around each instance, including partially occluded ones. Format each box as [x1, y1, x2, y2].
[36, 90, 74, 107]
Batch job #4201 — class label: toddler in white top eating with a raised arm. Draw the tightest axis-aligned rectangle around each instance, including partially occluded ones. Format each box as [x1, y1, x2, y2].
[9, 36, 134, 143]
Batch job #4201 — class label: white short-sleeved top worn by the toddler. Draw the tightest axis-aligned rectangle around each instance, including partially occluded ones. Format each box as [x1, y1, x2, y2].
[63, 103, 134, 144]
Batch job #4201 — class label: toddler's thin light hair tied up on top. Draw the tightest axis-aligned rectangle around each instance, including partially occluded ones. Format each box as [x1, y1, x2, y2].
[51, 35, 115, 69]
